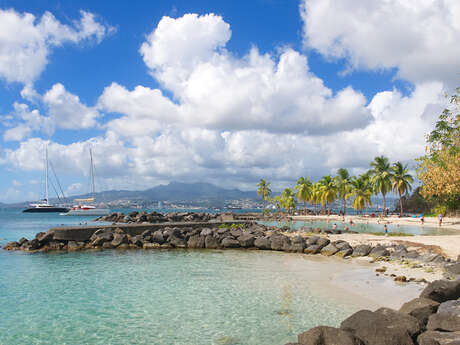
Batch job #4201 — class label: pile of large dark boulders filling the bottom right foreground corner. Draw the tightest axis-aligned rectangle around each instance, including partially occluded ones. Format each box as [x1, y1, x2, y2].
[286, 280, 460, 345]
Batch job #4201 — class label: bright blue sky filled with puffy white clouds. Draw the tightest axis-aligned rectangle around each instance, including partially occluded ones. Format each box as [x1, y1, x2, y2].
[0, 0, 460, 203]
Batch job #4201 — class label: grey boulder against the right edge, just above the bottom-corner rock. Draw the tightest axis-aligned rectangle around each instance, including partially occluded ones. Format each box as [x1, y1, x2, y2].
[427, 300, 460, 330]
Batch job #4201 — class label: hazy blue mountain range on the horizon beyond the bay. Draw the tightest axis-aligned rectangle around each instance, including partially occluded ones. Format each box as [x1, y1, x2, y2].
[0, 182, 257, 207]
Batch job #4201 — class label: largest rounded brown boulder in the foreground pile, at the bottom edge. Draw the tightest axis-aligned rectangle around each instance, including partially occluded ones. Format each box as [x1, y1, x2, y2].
[340, 308, 422, 345]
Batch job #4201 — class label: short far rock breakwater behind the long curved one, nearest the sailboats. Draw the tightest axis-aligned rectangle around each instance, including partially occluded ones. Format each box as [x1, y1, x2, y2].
[96, 211, 220, 224]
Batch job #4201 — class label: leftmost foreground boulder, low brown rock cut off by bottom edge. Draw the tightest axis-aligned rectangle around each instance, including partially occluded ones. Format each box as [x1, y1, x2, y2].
[297, 326, 364, 345]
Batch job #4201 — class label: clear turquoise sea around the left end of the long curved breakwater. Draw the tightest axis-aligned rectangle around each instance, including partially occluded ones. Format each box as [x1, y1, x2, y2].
[0, 210, 422, 345]
